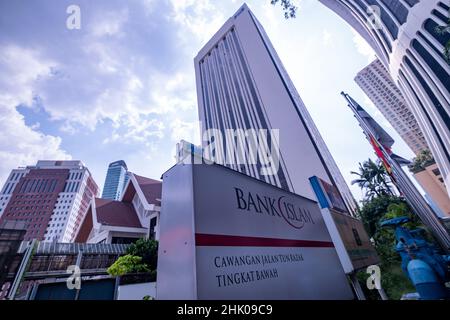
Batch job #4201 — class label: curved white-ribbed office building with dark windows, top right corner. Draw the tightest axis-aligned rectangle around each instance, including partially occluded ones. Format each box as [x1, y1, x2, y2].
[320, 0, 450, 194]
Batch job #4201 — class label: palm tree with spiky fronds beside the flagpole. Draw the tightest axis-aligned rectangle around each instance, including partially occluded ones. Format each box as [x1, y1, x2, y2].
[350, 159, 393, 199]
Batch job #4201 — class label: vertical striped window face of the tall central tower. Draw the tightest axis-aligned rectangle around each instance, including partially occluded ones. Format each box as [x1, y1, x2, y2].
[200, 28, 289, 190]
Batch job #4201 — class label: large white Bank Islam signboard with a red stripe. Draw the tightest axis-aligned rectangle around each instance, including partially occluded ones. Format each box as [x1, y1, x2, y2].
[157, 165, 353, 299]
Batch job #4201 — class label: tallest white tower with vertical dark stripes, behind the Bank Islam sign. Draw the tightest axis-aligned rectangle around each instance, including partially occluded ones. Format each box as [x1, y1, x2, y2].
[195, 4, 356, 212]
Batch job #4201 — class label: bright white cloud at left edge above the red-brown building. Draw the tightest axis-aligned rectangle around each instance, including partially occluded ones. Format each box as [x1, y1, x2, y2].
[0, 46, 70, 181]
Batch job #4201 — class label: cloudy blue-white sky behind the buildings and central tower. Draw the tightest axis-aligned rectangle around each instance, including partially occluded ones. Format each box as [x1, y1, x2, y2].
[0, 0, 414, 199]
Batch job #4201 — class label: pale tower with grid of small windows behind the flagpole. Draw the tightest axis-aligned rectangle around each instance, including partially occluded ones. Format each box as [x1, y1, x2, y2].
[355, 59, 429, 155]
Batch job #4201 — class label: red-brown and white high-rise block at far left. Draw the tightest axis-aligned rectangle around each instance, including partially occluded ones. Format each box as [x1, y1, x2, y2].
[0, 160, 98, 242]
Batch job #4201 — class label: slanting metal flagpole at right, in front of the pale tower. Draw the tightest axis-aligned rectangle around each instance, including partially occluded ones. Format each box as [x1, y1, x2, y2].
[341, 92, 450, 252]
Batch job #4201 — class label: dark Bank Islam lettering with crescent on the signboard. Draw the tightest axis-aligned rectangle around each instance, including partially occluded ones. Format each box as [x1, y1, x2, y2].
[234, 188, 315, 229]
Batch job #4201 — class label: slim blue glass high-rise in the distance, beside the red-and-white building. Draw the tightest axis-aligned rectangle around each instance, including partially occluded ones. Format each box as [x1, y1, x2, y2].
[102, 160, 129, 200]
